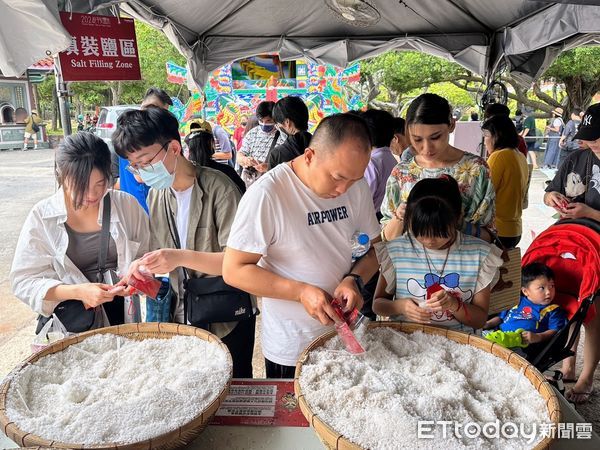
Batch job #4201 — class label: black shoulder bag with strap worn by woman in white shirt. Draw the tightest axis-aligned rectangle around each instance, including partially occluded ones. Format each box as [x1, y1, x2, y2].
[35, 194, 116, 334]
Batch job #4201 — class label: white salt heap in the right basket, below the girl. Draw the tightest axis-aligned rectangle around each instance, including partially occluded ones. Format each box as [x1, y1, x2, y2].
[300, 328, 550, 450]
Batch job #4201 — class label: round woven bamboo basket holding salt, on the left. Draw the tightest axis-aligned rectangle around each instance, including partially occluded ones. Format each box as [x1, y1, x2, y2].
[0, 323, 232, 450]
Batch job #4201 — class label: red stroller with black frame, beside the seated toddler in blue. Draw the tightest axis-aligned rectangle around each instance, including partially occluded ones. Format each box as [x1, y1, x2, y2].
[521, 219, 600, 381]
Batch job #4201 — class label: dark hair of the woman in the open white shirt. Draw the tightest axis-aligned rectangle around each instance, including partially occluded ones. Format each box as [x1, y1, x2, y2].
[56, 131, 112, 209]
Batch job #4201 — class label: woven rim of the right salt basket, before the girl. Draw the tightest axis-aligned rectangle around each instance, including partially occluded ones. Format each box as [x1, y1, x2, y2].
[294, 322, 562, 450]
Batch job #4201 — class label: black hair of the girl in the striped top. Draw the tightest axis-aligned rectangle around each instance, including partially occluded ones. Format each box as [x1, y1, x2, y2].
[404, 175, 462, 238]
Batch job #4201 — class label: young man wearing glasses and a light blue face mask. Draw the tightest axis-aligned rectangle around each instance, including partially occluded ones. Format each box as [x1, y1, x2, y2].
[112, 108, 256, 378]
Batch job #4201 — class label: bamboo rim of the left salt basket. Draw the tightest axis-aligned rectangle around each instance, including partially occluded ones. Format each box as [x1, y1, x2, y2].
[0, 322, 233, 450]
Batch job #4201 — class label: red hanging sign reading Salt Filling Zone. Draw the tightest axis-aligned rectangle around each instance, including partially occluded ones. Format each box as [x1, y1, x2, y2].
[59, 12, 142, 81]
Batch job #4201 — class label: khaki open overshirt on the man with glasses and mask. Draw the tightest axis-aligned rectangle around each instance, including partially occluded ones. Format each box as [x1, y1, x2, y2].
[147, 167, 241, 337]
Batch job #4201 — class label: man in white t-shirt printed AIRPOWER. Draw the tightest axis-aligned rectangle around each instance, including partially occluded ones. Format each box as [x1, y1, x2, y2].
[223, 114, 380, 378]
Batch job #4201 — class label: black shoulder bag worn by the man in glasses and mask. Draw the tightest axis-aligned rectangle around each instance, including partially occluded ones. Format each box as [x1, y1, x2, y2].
[164, 190, 256, 329]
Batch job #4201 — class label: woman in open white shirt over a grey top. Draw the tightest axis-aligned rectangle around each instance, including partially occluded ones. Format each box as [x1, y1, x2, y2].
[10, 132, 149, 331]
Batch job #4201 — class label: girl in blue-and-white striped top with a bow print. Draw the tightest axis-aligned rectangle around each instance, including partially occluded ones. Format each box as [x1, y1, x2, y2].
[373, 175, 502, 329]
